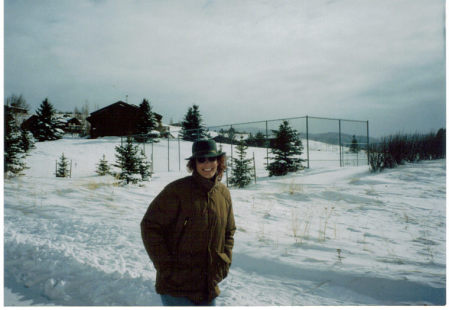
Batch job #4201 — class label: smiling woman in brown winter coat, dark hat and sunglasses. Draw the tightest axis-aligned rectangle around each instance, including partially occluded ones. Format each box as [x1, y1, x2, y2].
[141, 140, 236, 306]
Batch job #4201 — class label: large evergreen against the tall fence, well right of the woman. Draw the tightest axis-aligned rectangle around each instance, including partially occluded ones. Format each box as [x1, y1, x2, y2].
[267, 121, 304, 177]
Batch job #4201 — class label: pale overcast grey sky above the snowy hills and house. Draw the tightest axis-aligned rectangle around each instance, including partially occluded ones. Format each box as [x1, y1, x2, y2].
[4, 0, 446, 136]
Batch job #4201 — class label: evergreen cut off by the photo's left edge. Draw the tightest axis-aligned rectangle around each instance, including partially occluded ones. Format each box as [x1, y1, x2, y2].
[3, 109, 27, 176]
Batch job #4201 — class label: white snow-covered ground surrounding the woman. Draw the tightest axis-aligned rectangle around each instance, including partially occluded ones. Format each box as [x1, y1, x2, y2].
[4, 138, 446, 306]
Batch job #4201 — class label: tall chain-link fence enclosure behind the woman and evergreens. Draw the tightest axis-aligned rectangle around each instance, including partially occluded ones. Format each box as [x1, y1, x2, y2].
[128, 116, 369, 176]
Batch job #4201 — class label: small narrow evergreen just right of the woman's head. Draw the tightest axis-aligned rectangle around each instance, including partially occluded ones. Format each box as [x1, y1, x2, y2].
[229, 140, 253, 188]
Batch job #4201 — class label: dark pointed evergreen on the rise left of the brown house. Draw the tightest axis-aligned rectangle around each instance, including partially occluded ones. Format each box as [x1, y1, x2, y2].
[33, 98, 62, 141]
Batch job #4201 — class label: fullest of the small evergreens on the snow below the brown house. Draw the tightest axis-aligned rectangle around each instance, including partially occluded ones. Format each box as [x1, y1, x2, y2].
[114, 137, 140, 184]
